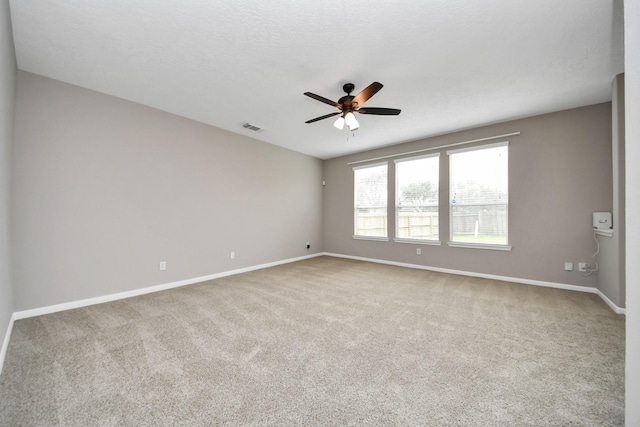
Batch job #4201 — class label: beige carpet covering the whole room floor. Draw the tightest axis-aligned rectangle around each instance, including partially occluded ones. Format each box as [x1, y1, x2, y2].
[0, 257, 624, 426]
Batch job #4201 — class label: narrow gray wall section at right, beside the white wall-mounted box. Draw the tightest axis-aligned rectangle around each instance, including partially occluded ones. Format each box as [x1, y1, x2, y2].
[597, 74, 625, 307]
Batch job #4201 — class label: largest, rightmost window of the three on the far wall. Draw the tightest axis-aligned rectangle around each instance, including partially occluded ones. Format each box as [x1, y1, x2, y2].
[447, 142, 509, 249]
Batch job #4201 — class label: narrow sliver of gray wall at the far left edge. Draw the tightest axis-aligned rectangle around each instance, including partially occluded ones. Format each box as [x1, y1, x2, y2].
[0, 0, 16, 348]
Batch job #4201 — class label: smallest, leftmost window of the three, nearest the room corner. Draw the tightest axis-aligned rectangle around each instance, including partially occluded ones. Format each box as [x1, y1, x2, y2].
[353, 163, 387, 240]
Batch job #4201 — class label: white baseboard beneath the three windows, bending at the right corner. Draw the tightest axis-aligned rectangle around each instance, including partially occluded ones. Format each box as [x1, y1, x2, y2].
[324, 252, 626, 314]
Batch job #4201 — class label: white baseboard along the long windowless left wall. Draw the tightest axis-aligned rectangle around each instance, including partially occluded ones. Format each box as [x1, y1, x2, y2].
[13, 253, 324, 320]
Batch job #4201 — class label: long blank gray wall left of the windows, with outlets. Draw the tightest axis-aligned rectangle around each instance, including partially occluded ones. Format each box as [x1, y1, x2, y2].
[13, 71, 323, 310]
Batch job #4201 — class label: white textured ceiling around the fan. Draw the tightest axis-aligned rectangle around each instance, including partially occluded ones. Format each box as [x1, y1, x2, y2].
[10, 0, 623, 158]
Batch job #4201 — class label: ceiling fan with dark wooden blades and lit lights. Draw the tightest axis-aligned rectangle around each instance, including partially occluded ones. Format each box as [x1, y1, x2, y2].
[304, 82, 400, 131]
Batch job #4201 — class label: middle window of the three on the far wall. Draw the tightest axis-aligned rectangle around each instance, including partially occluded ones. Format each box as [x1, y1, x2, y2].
[396, 154, 440, 241]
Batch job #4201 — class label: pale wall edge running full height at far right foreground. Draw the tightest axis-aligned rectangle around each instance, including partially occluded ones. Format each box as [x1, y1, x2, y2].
[624, 0, 640, 426]
